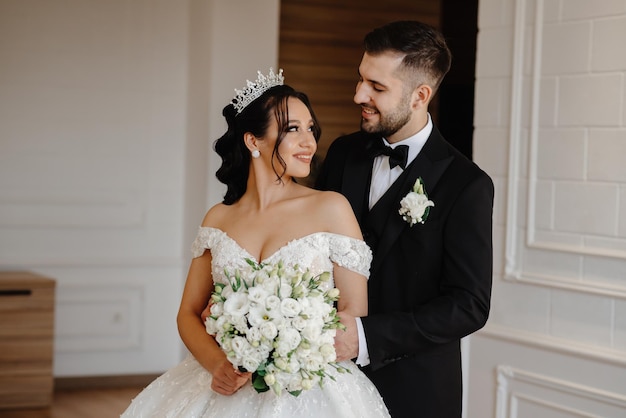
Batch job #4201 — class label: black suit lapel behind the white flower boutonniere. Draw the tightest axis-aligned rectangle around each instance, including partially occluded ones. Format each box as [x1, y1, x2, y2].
[369, 127, 453, 274]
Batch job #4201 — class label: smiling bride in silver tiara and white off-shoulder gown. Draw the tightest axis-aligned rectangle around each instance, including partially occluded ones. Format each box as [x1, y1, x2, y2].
[122, 69, 389, 418]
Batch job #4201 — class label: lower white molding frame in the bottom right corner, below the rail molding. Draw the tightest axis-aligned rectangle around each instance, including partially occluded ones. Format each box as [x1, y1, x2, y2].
[496, 365, 626, 418]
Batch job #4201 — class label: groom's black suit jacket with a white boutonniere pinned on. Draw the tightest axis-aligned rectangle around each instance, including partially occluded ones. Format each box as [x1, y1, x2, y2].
[317, 127, 494, 418]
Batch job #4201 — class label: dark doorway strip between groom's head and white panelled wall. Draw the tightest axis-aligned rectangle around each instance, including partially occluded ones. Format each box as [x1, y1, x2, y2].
[437, 0, 478, 159]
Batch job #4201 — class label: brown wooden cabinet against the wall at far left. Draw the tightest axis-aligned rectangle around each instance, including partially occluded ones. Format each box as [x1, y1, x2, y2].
[0, 271, 55, 409]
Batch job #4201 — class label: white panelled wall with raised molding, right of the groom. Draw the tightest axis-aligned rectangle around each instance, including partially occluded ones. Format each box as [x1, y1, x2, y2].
[467, 0, 626, 418]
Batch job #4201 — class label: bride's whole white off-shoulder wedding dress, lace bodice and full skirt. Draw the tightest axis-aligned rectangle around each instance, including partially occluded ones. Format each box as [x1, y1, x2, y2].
[122, 227, 389, 418]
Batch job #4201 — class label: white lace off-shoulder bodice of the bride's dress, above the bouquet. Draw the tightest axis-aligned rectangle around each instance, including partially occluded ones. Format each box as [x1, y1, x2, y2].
[191, 227, 372, 287]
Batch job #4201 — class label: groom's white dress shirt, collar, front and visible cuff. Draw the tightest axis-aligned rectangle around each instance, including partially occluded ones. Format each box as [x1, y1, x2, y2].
[356, 113, 433, 366]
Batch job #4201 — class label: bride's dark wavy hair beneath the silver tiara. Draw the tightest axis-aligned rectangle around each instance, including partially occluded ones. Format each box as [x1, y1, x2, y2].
[213, 85, 322, 205]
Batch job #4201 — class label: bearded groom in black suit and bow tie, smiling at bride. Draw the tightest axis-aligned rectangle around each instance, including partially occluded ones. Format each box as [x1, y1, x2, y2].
[317, 21, 494, 418]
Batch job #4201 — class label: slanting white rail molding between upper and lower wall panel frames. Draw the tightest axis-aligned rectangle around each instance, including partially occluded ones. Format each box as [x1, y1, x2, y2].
[474, 324, 626, 367]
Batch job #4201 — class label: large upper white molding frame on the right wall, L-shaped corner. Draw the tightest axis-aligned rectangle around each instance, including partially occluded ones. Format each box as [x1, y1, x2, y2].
[504, 0, 626, 299]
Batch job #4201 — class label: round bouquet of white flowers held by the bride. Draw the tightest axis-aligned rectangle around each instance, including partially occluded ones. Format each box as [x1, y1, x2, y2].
[205, 259, 347, 396]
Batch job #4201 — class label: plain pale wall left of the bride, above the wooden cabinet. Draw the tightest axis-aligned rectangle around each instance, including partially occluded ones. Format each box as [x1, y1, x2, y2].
[0, 0, 279, 376]
